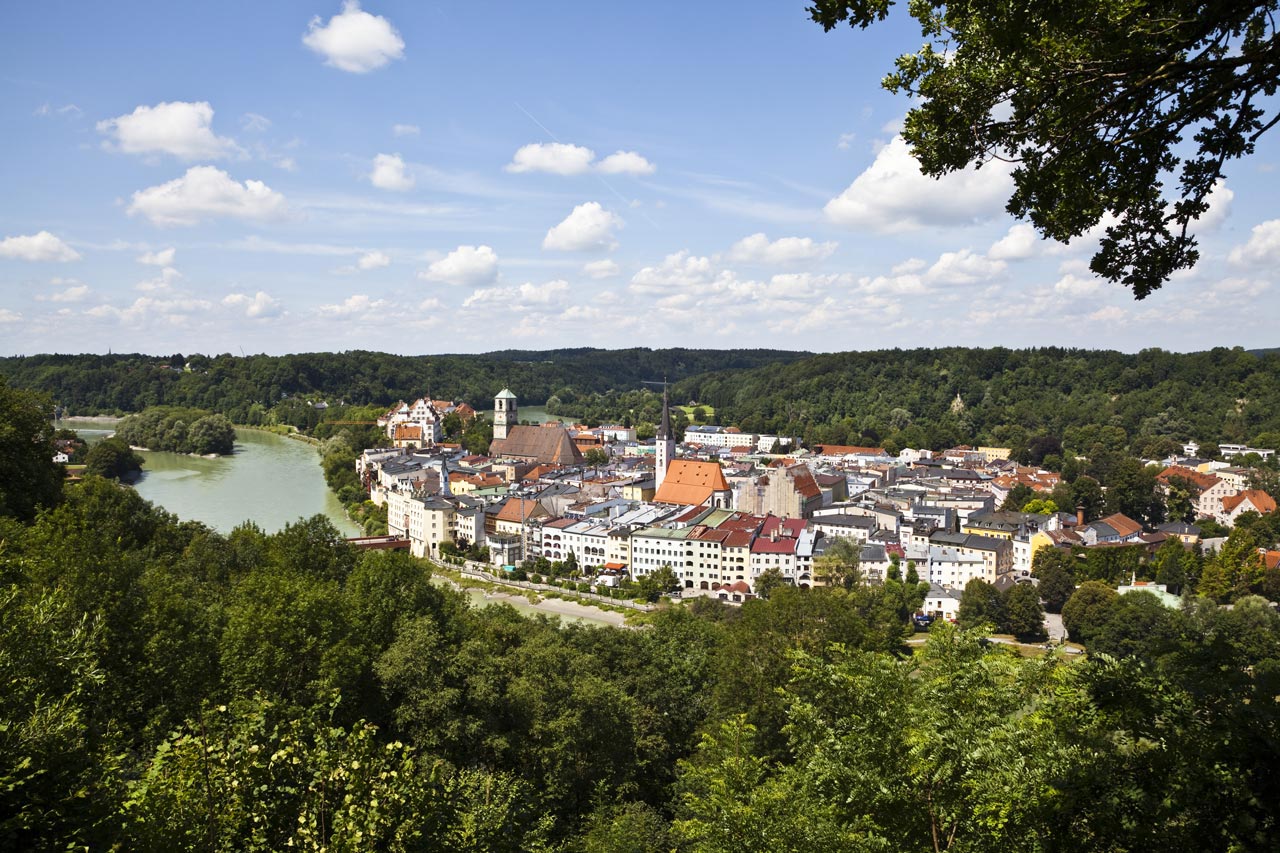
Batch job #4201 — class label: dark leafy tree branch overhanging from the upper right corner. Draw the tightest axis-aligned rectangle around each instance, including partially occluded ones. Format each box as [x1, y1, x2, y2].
[809, 0, 1277, 298]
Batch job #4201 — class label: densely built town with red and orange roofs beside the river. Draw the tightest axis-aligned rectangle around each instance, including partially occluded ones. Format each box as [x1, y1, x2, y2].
[356, 389, 1280, 621]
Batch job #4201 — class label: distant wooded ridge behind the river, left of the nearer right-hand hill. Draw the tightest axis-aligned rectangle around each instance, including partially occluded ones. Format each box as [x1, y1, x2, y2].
[0, 348, 810, 423]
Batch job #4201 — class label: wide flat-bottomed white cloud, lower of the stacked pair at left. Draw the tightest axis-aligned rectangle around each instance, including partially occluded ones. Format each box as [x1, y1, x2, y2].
[129, 167, 285, 225]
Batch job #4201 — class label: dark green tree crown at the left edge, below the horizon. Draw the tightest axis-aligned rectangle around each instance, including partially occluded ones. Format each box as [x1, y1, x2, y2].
[0, 378, 63, 520]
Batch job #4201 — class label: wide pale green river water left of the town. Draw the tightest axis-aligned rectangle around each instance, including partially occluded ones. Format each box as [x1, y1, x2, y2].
[58, 419, 361, 537]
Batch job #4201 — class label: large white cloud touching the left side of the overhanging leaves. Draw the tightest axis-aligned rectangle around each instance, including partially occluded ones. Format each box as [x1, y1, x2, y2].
[823, 136, 1012, 233]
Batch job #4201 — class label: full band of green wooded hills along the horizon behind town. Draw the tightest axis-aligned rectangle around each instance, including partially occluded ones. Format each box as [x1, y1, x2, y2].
[10, 347, 1280, 464]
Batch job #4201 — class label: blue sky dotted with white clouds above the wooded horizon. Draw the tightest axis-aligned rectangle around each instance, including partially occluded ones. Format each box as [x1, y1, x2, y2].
[0, 0, 1280, 355]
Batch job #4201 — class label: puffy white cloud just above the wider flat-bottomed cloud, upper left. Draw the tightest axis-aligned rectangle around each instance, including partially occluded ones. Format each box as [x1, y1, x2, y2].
[97, 101, 239, 160]
